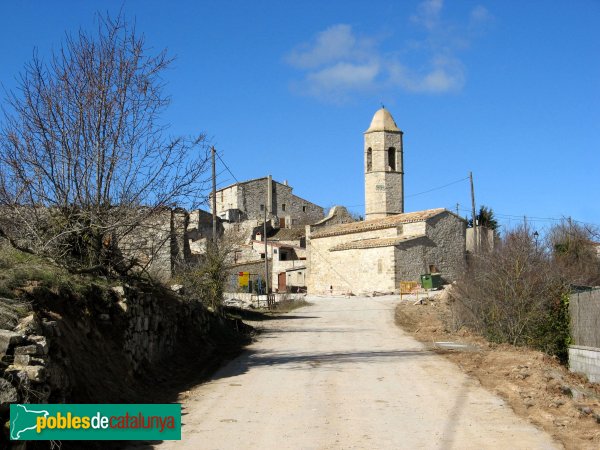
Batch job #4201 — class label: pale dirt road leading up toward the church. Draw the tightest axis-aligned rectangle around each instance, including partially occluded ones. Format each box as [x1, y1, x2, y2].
[155, 297, 560, 450]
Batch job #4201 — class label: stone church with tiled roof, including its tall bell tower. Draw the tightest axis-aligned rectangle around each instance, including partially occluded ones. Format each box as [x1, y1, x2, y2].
[306, 108, 466, 295]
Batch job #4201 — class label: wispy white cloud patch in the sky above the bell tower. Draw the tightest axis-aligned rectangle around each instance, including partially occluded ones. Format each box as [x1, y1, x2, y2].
[285, 0, 492, 102]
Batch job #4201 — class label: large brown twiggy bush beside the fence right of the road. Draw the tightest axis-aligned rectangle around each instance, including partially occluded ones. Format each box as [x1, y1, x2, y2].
[450, 226, 569, 360]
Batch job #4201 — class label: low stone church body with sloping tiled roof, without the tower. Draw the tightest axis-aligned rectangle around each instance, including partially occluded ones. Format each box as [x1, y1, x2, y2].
[307, 208, 466, 295]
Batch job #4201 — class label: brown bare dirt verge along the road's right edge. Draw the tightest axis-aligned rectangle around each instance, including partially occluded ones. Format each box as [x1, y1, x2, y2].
[395, 293, 600, 449]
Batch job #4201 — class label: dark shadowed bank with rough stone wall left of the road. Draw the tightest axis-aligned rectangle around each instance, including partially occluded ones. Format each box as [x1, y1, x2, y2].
[0, 285, 241, 416]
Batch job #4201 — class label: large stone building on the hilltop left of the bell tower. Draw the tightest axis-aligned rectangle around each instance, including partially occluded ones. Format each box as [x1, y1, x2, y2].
[210, 175, 324, 228]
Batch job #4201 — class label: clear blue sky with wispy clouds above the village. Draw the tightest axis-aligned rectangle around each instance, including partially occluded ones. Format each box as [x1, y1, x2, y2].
[0, 0, 600, 230]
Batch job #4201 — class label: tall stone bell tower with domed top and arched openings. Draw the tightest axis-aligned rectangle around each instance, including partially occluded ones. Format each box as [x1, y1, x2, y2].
[364, 108, 404, 220]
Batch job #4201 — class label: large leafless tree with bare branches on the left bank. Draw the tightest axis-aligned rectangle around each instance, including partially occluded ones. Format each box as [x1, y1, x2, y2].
[0, 15, 208, 272]
